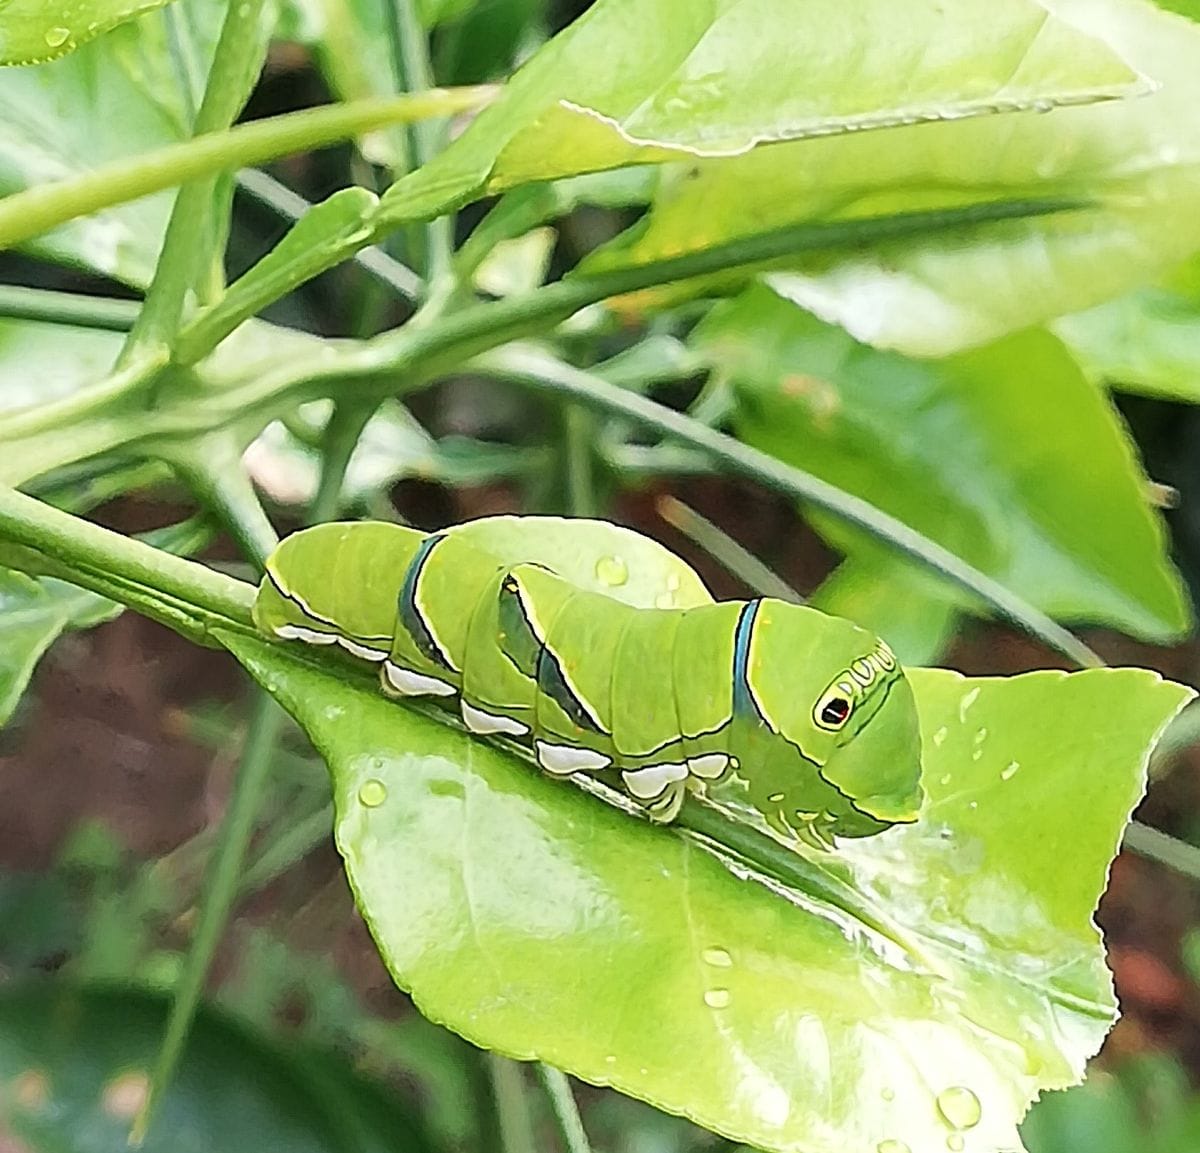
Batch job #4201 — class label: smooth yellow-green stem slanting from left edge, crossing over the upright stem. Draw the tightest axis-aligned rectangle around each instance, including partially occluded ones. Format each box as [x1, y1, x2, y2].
[0, 88, 496, 248]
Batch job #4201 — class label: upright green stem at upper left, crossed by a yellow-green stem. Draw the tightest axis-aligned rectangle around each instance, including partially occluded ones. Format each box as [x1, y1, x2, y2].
[116, 0, 266, 368]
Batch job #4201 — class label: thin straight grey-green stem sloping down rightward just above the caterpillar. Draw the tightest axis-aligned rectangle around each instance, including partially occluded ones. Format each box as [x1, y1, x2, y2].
[472, 344, 1104, 668]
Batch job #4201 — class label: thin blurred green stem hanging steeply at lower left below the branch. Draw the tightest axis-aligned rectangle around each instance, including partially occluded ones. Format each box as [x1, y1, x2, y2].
[130, 692, 283, 1145]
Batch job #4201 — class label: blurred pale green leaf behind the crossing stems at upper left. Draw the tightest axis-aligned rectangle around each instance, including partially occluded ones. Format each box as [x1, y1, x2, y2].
[0, 0, 226, 284]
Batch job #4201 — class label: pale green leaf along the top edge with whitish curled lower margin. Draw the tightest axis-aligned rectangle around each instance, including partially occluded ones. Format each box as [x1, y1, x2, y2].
[383, 0, 1138, 229]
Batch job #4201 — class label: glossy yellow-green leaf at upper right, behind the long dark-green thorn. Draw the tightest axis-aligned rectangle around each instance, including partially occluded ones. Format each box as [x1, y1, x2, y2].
[595, 0, 1200, 354]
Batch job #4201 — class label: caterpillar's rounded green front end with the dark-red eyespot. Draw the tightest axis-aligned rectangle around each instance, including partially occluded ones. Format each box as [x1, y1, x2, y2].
[746, 601, 922, 835]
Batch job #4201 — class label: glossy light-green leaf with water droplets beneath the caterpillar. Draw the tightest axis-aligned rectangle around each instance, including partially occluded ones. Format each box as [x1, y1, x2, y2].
[221, 523, 1192, 1153]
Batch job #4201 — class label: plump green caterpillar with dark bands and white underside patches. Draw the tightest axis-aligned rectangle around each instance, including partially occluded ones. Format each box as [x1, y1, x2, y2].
[254, 517, 922, 846]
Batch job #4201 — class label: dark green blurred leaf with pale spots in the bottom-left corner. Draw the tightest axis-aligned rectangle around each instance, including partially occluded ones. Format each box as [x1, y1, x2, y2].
[0, 983, 427, 1153]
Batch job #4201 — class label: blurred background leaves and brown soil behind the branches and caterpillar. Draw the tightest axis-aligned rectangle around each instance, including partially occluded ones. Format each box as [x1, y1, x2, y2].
[0, 0, 1200, 1153]
